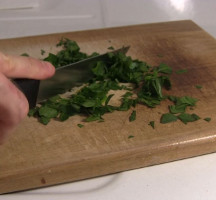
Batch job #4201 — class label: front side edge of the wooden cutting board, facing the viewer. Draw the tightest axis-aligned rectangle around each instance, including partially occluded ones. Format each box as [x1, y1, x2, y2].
[0, 133, 216, 194]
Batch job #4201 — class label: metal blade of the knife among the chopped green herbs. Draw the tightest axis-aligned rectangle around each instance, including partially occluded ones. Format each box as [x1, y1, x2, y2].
[37, 46, 130, 103]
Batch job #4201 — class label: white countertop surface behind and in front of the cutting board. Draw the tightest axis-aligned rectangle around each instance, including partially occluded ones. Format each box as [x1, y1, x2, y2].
[0, 0, 216, 200]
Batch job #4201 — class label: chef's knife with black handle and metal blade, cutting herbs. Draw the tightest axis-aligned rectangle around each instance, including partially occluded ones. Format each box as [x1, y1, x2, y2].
[13, 46, 130, 108]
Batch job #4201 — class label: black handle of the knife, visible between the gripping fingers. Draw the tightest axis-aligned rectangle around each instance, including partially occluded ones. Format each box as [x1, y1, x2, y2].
[12, 78, 40, 109]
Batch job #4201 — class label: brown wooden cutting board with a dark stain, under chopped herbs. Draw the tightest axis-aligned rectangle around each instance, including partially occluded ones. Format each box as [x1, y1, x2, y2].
[0, 21, 216, 193]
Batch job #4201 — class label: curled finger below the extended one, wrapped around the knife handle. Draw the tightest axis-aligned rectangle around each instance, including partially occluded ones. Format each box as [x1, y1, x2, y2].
[0, 73, 29, 143]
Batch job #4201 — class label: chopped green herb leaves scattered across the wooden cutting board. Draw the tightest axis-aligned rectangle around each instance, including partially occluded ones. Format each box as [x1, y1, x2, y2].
[29, 38, 210, 125]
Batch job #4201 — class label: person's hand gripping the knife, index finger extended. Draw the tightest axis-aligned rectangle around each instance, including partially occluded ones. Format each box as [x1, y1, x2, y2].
[0, 52, 55, 143]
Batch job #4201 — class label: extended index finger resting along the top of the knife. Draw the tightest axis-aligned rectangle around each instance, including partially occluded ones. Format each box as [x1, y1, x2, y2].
[0, 52, 55, 80]
